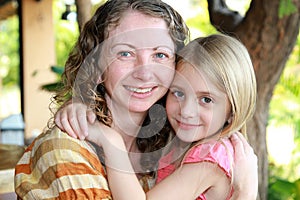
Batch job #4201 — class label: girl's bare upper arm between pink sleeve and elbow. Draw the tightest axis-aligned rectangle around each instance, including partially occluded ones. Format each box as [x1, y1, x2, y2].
[147, 162, 230, 200]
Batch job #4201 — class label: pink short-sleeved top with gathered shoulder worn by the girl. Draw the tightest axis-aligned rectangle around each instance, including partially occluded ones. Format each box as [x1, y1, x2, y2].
[156, 138, 234, 200]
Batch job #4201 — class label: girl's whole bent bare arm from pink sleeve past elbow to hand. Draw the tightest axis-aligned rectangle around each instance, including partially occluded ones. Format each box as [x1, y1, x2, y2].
[87, 123, 230, 200]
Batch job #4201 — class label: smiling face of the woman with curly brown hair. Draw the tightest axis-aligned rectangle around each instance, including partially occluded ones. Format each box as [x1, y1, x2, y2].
[103, 11, 175, 112]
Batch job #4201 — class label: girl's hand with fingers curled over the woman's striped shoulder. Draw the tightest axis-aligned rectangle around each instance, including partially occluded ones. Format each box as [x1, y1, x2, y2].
[54, 100, 96, 140]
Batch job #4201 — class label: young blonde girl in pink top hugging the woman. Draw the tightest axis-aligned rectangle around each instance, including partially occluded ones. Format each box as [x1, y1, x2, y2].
[67, 34, 257, 200]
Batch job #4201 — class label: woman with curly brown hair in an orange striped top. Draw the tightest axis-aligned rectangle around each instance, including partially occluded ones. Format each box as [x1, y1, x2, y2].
[15, 0, 258, 199]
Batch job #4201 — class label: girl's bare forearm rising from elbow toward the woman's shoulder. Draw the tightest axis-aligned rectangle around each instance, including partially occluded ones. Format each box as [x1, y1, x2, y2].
[87, 122, 146, 200]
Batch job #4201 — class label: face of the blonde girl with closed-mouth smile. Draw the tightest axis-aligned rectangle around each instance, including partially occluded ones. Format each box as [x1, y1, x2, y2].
[166, 63, 231, 142]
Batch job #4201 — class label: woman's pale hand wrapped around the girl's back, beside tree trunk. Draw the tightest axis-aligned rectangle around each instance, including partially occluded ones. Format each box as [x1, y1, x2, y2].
[230, 133, 258, 200]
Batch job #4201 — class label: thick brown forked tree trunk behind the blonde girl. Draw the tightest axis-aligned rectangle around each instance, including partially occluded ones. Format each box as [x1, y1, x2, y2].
[208, 0, 300, 200]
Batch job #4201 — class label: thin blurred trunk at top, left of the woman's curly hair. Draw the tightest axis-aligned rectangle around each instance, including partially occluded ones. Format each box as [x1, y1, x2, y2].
[75, 0, 92, 30]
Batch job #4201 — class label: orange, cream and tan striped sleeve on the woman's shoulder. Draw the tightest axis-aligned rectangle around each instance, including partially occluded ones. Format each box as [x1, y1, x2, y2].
[15, 128, 112, 199]
